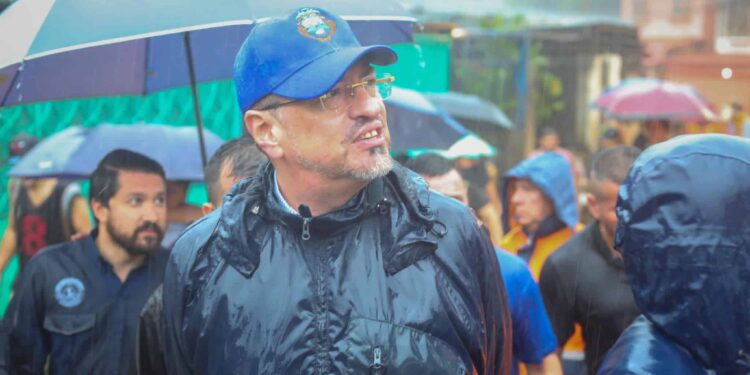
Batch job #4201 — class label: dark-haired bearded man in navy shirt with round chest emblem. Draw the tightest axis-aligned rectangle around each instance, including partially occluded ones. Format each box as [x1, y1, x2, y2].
[3, 150, 167, 374]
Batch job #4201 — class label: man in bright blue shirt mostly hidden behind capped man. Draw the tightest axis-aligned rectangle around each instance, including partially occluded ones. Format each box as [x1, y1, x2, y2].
[406, 153, 562, 375]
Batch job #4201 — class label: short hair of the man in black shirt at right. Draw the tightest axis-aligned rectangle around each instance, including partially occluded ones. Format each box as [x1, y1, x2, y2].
[589, 146, 641, 194]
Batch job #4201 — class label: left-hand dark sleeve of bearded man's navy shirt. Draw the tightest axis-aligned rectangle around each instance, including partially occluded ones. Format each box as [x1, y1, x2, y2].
[1, 256, 50, 374]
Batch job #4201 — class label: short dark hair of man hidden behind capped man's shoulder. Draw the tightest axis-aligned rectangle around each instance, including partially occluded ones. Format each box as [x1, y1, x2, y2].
[203, 136, 266, 202]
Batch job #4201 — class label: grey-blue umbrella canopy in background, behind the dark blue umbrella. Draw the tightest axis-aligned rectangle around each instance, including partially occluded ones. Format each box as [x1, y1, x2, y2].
[425, 92, 513, 129]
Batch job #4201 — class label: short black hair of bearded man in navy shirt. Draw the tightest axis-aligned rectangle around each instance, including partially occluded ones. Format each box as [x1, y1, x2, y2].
[89, 149, 166, 207]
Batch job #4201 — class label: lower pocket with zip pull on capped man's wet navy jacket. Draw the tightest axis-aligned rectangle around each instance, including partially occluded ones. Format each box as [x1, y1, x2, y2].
[341, 318, 475, 375]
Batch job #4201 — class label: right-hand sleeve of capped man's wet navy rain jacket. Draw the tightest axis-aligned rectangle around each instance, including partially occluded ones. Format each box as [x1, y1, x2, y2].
[472, 227, 513, 375]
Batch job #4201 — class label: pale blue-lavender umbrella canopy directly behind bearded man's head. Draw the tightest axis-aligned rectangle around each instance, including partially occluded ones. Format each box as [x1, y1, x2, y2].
[8, 124, 223, 181]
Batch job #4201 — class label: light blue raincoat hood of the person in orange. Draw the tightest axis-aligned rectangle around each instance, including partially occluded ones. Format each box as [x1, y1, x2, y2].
[502, 152, 578, 232]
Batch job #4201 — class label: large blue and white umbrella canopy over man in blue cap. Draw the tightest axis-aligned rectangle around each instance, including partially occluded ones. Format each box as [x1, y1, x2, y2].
[0, 0, 416, 106]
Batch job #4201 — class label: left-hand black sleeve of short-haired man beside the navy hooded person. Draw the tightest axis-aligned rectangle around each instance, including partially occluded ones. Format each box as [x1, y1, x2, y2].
[539, 260, 575, 347]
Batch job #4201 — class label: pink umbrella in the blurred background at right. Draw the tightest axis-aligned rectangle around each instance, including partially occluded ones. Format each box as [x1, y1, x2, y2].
[595, 79, 718, 122]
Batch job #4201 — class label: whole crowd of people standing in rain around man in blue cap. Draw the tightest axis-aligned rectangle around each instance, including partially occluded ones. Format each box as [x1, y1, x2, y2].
[0, 8, 750, 375]
